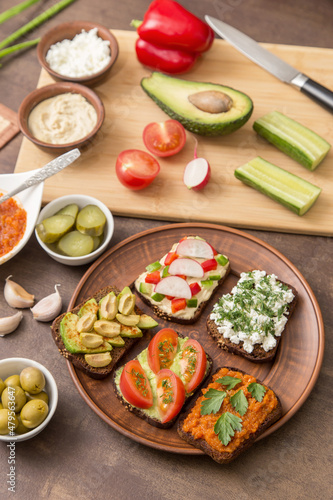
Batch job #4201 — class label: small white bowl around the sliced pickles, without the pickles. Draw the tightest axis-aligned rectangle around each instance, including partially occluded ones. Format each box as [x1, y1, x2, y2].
[35, 194, 114, 266]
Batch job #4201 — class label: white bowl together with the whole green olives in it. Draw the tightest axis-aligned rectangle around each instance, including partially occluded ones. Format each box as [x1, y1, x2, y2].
[0, 358, 58, 442]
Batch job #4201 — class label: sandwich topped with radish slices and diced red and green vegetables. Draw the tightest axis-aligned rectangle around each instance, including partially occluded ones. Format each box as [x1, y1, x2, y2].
[134, 236, 230, 324]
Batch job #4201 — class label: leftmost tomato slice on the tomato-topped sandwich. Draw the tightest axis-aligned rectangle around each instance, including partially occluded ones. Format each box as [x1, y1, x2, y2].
[119, 359, 153, 409]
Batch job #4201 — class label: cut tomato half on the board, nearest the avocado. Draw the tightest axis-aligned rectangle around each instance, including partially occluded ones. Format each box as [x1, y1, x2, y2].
[143, 120, 186, 156]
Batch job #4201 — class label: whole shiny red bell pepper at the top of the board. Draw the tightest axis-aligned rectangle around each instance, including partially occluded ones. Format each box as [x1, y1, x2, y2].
[132, 0, 214, 74]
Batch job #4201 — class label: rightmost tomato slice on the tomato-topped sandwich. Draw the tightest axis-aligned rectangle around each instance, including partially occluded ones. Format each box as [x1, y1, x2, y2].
[180, 339, 207, 393]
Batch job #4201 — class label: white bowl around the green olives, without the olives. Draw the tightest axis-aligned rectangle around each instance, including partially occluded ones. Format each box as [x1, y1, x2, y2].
[0, 358, 58, 442]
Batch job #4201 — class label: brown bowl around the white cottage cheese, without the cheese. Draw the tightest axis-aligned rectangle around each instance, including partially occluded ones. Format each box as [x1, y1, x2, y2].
[37, 21, 119, 86]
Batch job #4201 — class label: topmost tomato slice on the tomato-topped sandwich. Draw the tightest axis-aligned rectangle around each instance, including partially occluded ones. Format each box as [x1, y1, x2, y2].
[148, 328, 178, 373]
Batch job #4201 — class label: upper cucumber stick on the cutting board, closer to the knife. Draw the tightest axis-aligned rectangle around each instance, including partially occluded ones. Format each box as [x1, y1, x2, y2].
[253, 111, 331, 170]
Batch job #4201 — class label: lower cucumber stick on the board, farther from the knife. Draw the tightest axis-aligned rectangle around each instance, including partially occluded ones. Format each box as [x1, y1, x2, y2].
[235, 156, 321, 215]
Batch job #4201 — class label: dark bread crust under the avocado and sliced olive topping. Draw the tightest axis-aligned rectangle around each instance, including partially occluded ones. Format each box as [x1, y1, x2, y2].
[51, 286, 144, 379]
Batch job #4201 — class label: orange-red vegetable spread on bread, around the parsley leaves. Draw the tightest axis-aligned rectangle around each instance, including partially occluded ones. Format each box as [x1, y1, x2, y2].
[183, 368, 279, 453]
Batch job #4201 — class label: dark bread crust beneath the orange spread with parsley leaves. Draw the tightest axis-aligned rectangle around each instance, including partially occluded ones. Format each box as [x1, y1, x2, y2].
[177, 367, 282, 464]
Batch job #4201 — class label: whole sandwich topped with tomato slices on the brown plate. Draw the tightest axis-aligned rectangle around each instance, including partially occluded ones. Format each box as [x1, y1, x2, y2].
[113, 328, 212, 428]
